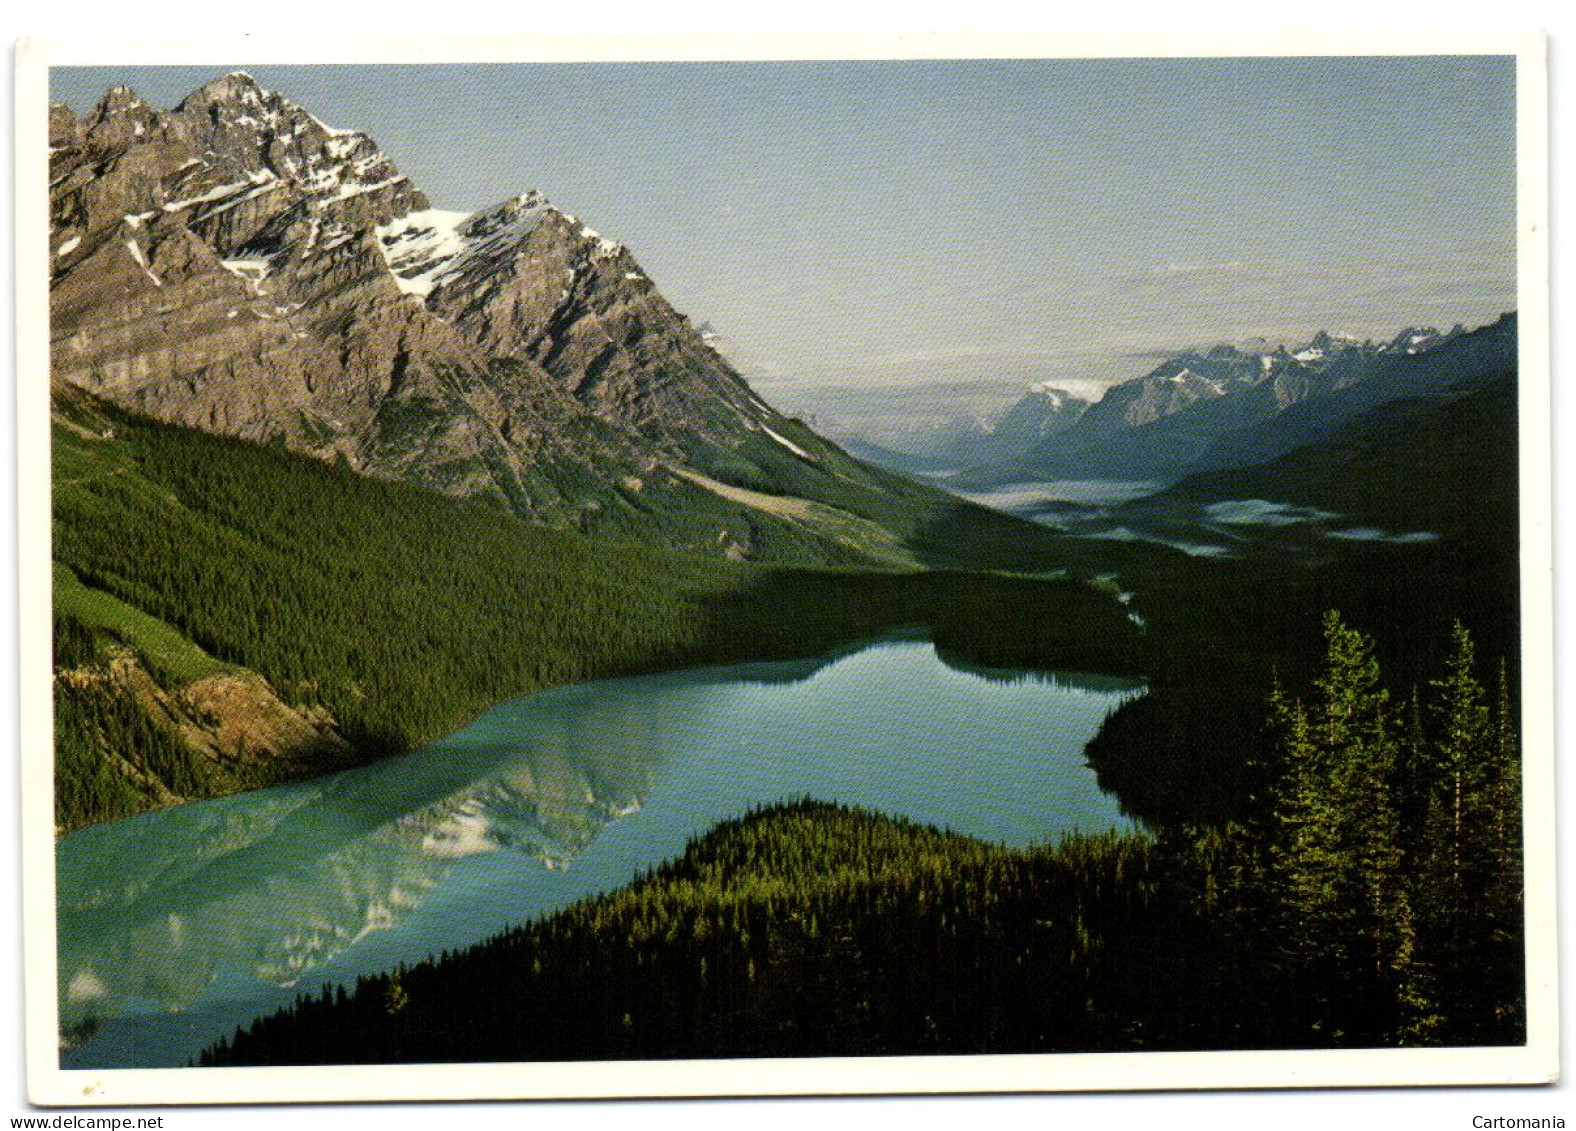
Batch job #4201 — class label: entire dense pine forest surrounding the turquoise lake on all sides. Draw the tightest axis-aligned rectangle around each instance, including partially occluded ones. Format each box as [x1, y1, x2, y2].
[54, 359, 1524, 1063]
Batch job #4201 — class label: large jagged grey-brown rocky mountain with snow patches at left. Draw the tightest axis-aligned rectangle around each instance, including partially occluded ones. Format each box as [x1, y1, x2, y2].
[50, 71, 846, 541]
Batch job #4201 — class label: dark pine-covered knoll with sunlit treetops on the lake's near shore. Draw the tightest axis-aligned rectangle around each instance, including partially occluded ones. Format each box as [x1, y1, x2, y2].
[205, 802, 1179, 1063]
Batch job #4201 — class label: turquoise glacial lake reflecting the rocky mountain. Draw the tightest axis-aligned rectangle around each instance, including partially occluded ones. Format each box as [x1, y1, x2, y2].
[55, 638, 1143, 1068]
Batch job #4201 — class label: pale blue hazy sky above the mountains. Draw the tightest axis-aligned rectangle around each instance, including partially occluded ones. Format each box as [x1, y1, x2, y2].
[52, 58, 1515, 425]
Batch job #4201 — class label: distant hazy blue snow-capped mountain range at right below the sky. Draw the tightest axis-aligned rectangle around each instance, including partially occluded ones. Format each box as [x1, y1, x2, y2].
[846, 315, 1516, 487]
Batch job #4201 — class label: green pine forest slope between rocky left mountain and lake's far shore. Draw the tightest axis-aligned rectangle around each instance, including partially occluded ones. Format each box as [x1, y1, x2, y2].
[54, 395, 1143, 829]
